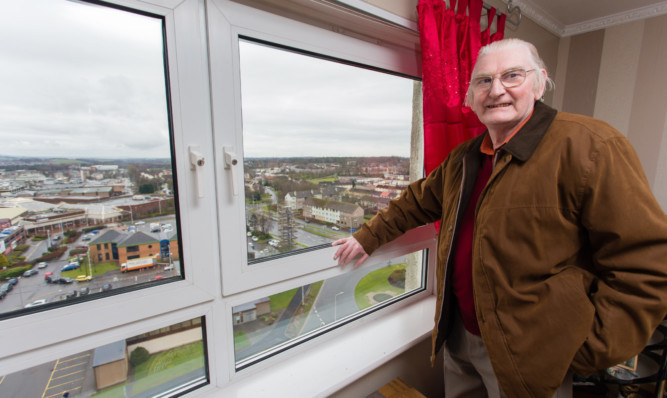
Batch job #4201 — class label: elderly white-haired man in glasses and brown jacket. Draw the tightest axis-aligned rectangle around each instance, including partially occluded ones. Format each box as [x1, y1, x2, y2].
[333, 39, 667, 398]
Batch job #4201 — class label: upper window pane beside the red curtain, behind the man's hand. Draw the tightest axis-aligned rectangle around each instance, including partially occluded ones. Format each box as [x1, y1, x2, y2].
[239, 40, 413, 263]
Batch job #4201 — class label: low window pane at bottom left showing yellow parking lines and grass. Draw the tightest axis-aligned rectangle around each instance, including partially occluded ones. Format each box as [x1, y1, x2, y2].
[0, 318, 208, 398]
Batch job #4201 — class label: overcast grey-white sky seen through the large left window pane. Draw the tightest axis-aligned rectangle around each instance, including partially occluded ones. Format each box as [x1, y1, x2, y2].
[0, 0, 170, 158]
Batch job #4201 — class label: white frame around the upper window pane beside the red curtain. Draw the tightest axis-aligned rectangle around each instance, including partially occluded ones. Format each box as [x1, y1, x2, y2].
[208, 0, 433, 296]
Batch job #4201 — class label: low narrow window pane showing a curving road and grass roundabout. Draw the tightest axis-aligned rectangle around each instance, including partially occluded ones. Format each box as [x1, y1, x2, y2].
[232, 251, 425, 369]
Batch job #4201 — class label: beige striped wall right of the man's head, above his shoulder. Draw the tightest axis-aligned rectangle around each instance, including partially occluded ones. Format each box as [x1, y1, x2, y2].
[554, 15, 667, 209]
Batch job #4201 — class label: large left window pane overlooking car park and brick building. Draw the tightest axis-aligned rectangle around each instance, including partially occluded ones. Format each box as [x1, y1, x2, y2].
[0, 0, 180, 316]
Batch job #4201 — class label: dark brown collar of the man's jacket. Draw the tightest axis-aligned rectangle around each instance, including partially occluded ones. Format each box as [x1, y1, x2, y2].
[457, 101, 558, 162]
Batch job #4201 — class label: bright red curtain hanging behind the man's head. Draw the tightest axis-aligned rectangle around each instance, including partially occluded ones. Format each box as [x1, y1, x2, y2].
[417, 0, 505, 174]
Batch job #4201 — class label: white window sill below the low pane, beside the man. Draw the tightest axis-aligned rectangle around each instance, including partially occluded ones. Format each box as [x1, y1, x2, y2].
[210, 296, 436, 397]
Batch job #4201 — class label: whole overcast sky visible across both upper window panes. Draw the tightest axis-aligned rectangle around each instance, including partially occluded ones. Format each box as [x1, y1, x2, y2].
[0, 0, 412, 158]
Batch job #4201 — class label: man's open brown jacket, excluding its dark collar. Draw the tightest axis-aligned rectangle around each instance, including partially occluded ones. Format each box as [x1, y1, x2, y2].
[354, 102, 667, 397]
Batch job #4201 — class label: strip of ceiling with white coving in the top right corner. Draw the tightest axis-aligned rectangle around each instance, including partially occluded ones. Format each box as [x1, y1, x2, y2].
[516, 0, 667, 36]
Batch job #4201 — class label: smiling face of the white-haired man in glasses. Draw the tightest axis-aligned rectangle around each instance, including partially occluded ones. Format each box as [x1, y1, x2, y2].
[472, 47, 543, 136]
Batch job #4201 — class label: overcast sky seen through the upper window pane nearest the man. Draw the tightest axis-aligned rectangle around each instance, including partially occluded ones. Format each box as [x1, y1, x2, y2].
[240, 42, 413, 157]
